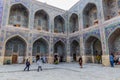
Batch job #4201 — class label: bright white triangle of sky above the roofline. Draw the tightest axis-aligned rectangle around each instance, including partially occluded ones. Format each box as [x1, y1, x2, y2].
[37, 0, 79, 10]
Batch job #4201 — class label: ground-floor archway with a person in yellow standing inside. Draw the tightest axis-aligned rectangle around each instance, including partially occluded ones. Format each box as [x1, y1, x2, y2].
[85, 36, 102, 63]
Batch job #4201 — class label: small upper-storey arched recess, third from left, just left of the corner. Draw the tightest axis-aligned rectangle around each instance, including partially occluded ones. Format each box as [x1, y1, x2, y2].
[54, 15, 65, 33]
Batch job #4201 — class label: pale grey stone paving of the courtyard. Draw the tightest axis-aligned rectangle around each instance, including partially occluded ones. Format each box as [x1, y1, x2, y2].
[0, 63, 120, 80]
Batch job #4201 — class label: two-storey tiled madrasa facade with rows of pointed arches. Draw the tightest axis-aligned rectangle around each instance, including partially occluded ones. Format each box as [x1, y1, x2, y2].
[0, 0, 120, 66]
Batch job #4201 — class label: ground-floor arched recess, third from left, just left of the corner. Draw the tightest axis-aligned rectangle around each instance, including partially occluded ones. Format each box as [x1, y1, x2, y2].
[54, 41, 66, 62]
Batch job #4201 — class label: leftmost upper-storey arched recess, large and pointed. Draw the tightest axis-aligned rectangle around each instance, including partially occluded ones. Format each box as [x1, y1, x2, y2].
[9, 4, 29, 28]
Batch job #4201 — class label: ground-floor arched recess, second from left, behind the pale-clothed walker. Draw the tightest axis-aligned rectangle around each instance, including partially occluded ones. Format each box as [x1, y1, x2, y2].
[33, 38, 49, 60]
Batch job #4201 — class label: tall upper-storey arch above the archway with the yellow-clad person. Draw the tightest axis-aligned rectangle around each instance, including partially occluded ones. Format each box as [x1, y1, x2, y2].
[83, 3, 98, 28]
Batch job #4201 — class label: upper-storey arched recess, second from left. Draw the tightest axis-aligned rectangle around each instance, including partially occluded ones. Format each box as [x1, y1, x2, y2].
[34, 10, 49, 31]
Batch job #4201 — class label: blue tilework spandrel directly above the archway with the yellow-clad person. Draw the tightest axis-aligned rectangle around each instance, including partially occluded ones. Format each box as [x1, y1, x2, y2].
[83, 29, 100, 41]
